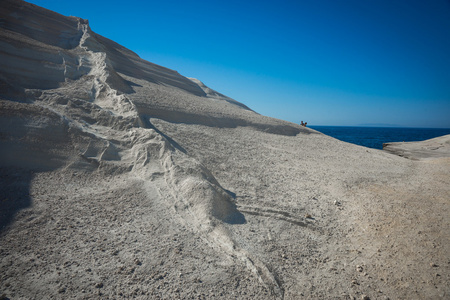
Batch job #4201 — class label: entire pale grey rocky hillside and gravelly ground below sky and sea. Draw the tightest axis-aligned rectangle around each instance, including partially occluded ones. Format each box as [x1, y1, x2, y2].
[0, 0, 450, 299]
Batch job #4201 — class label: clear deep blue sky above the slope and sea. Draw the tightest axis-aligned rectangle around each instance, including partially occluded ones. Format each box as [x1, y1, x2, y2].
[29, 0, 450, 128]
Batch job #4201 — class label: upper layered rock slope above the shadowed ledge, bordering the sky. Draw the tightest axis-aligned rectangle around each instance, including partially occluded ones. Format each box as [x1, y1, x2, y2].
[0, 0, 311, 135]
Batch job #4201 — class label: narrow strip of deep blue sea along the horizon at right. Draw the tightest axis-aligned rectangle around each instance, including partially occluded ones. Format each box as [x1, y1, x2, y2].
[308, 126, 450, 149]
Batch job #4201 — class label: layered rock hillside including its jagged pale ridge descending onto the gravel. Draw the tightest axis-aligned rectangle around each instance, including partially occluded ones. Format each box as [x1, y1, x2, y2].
[0, 0, 298, 296]
